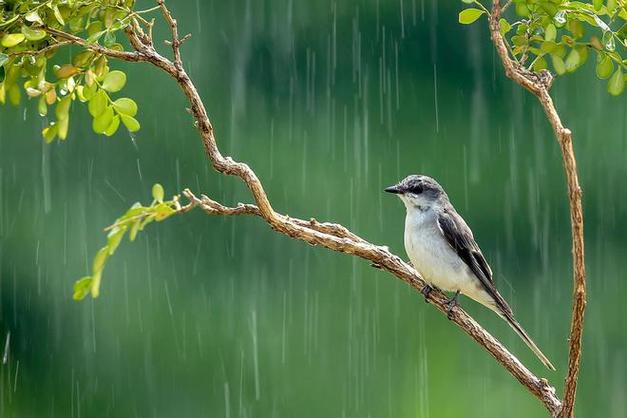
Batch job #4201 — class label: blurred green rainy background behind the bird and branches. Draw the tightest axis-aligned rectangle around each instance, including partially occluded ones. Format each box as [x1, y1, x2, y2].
[0, 0, 627, 418]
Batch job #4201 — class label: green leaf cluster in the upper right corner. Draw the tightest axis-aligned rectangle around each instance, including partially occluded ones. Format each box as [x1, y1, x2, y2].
[459, 0, 627, 96]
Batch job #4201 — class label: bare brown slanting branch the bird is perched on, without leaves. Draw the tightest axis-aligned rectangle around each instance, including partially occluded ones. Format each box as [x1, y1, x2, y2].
[49, 0, 561, 415]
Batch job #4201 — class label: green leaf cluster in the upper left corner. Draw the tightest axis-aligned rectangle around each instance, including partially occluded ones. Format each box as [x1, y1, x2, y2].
[0, 0, 140, 143]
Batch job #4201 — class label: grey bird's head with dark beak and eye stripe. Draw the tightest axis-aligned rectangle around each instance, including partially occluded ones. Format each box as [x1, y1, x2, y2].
[385, 174, 447, 210]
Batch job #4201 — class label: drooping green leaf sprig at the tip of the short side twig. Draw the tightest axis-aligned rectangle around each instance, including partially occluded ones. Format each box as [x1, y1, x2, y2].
[73, 183, 181, 300]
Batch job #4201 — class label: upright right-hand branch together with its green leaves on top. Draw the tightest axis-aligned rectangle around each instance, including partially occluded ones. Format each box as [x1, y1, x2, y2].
[460, 0, 592, 418]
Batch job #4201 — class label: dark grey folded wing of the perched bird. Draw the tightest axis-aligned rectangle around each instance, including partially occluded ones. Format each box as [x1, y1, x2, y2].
[438, 209, 510, 311]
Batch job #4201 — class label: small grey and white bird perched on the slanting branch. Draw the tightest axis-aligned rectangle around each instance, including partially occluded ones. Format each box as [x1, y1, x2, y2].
[385, 175, 555, 370]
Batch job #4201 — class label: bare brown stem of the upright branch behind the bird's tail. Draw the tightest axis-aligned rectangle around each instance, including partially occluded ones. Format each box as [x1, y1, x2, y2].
[489, 0, 586, 418]
